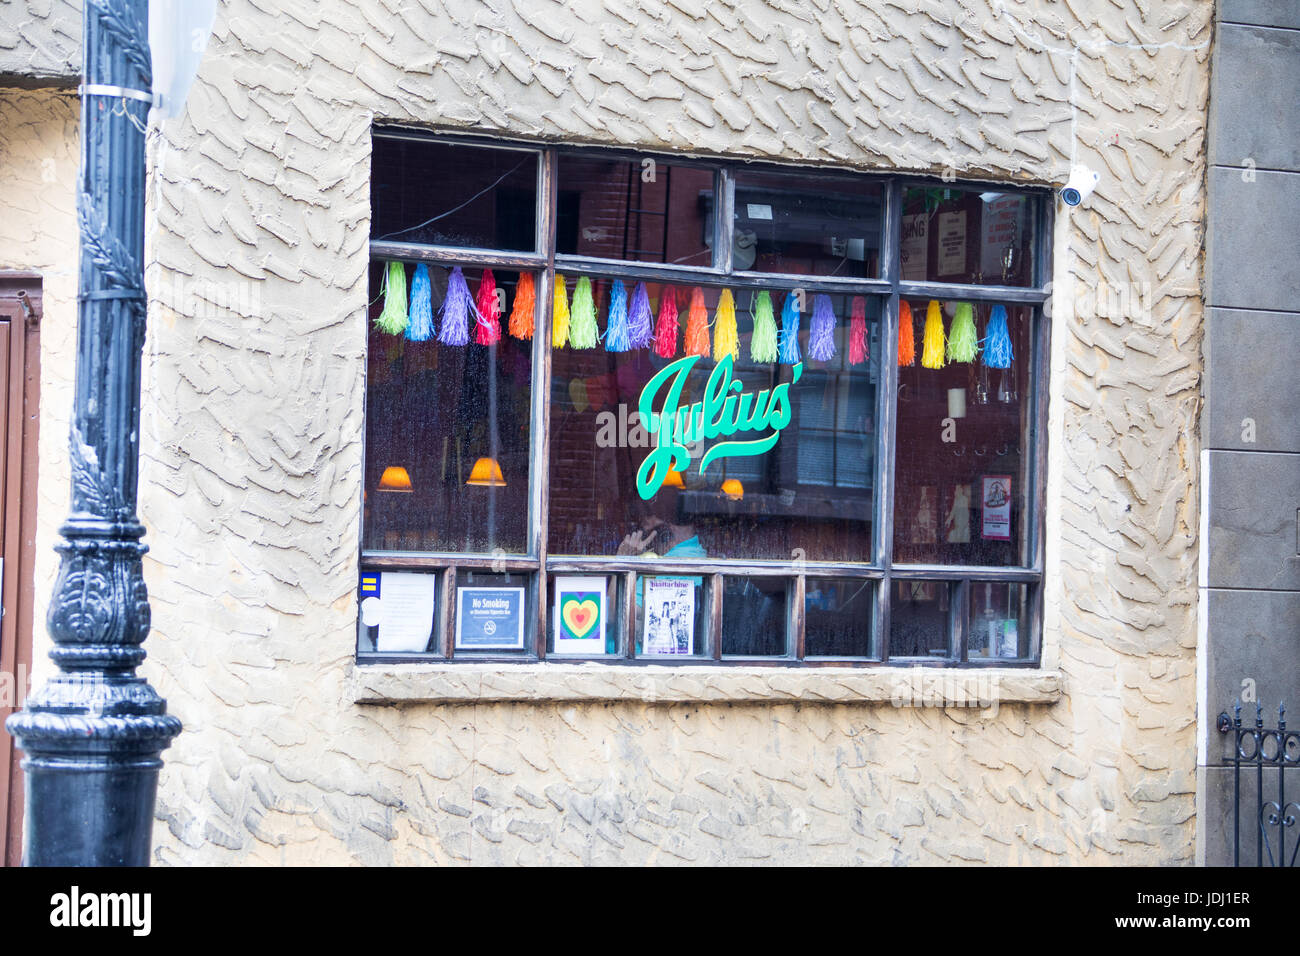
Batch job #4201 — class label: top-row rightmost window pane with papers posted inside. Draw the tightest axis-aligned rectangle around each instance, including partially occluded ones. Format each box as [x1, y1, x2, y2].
[900, 186, 1036, 286]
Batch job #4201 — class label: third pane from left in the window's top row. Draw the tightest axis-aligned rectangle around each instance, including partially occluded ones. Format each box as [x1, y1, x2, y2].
[732, 172, 881, 278]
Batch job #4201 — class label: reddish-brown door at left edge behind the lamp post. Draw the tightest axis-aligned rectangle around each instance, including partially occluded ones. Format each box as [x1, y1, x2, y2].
[0, 272, 42, 866]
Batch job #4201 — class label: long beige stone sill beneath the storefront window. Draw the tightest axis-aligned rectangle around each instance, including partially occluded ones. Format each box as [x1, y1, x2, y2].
[345, 662, 1061, 708]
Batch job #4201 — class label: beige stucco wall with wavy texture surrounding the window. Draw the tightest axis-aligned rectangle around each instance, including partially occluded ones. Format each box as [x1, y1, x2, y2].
[17, 0, 1212, 864]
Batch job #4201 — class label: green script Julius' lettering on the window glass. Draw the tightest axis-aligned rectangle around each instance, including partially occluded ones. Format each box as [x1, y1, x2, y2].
[637, 355, 803, 501]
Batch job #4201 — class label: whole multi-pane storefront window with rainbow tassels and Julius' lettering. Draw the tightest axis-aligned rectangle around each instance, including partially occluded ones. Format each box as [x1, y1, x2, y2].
[358, 130, 1049, 666]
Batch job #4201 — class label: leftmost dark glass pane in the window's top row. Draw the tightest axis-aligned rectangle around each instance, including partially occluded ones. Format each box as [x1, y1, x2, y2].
[371, 135, 537, 252]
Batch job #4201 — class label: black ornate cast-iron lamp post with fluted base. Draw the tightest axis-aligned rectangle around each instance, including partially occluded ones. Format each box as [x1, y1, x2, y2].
[7, 0, 181, 866]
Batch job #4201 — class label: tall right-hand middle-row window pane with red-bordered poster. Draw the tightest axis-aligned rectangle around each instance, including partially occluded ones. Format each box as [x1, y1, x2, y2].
[894, 300, 1032, 566]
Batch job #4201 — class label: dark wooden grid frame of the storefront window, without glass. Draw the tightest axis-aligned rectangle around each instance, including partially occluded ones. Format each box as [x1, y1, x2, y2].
[358, 126, 1054, 667]
